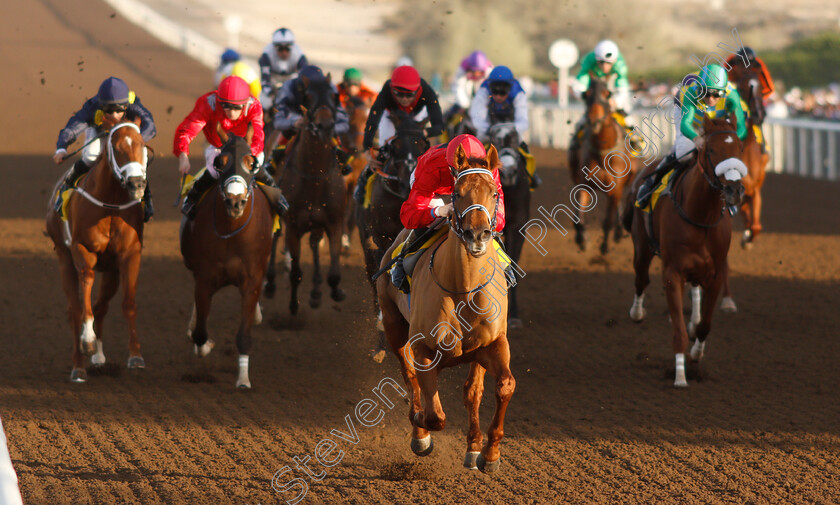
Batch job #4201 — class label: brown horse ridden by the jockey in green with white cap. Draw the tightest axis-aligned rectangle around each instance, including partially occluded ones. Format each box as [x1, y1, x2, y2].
[568, 78, 639, 254]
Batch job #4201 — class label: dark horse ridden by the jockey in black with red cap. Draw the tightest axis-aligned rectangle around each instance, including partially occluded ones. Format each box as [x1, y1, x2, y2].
[356, 111, 430, 350]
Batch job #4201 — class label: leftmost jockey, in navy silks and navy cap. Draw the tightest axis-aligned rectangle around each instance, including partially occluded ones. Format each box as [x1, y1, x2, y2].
[53, 77, 157, 222]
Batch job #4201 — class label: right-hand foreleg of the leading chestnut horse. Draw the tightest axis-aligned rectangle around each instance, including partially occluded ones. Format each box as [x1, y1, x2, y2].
[477, 334, 516, 473]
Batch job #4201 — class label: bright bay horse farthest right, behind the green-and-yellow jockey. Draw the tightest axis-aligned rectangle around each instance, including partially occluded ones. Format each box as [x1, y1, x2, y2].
[731, 66, 770, 249]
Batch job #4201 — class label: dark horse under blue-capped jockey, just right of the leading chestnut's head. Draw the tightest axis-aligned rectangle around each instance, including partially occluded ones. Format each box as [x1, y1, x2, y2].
[488, 123, 531, 328]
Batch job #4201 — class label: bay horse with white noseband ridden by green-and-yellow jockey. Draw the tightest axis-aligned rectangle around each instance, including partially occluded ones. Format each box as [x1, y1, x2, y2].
[623, 117, 747, 387]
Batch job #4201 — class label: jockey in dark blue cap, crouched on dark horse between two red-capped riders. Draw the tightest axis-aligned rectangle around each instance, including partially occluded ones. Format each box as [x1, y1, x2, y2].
[269, 65, 351, 175]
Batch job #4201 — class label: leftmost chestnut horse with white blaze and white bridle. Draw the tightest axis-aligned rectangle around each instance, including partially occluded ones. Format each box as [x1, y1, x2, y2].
[46, 121, 148, 382]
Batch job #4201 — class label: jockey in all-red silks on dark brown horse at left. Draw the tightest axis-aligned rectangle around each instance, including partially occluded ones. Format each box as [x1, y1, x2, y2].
[172, 76, 288, 219]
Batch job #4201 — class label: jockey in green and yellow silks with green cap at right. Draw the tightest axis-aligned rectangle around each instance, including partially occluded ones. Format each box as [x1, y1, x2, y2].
[637, 64, 749, 208]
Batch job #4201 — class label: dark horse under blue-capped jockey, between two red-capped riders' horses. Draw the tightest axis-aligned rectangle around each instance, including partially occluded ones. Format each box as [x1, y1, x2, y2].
[266, 74, 347, 314]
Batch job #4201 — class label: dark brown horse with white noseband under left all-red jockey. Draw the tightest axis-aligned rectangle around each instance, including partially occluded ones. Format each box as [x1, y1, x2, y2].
[181, 128, 274, 389]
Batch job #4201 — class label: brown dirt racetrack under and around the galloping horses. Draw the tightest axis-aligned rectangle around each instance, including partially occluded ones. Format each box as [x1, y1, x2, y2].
[0, 0, 840, 505]
